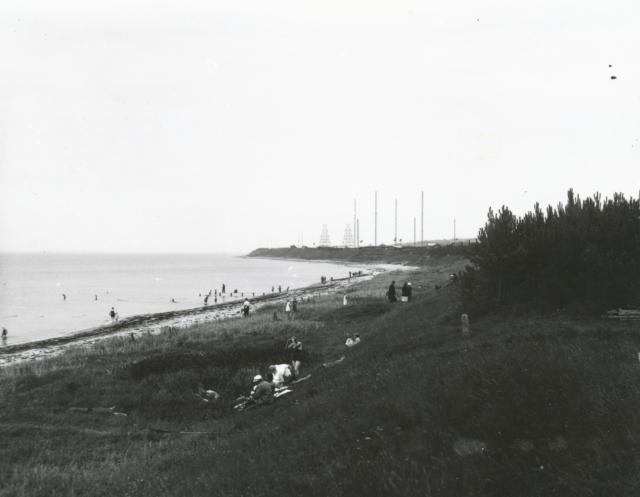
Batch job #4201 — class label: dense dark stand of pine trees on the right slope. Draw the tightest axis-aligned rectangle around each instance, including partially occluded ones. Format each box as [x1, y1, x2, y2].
[461, 190, 640, 311]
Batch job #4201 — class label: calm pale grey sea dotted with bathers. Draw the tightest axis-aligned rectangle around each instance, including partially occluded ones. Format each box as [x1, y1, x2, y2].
[0, 254, 354, 344]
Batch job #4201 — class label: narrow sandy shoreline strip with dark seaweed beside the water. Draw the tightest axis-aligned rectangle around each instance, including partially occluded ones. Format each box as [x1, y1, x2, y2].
[0, 261, 411, 368]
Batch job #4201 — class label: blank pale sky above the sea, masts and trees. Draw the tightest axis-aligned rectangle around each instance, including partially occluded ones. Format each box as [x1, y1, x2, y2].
[0, 0, 640, 253]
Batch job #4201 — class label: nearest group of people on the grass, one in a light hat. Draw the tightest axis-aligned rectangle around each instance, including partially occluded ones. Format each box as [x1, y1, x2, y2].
[234, 336, 302, 410]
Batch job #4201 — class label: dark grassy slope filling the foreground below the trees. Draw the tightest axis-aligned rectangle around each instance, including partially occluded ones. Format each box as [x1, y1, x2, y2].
[0, 258, 640, 496]
